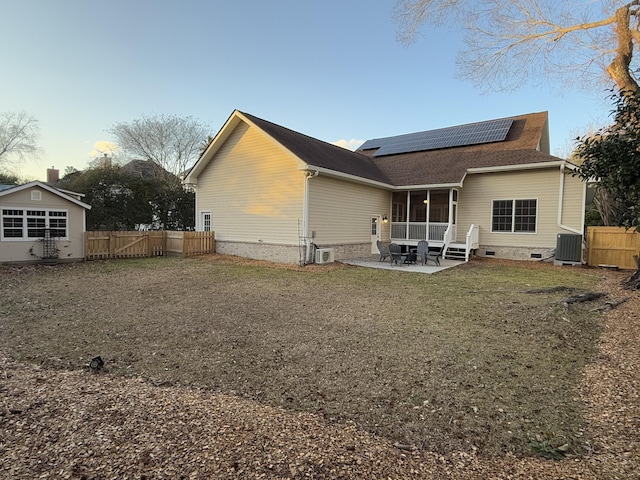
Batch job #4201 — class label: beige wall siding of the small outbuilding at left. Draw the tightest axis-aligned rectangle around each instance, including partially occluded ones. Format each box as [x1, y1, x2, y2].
[0, 186, 85, 262]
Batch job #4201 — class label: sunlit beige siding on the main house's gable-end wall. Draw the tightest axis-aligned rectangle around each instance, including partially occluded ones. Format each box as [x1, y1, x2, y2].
[196, 123, 305, 245]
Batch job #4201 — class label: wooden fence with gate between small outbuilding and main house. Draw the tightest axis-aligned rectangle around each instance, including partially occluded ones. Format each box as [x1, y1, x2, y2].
[84, 230, 215, 260]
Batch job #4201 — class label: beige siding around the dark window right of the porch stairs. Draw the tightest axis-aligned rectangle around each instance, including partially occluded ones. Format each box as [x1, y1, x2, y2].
[457, 168, 583, 248]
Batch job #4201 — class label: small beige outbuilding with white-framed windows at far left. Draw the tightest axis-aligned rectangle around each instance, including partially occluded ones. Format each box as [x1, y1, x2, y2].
[0, 181, 91, 263]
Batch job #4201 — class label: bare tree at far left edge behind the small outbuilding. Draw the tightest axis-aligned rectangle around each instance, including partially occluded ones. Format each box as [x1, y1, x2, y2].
[0, 112, 40, 165]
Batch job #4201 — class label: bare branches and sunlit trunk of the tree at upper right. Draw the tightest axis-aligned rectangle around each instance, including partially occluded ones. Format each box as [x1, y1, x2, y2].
[394, 0, 640, 91]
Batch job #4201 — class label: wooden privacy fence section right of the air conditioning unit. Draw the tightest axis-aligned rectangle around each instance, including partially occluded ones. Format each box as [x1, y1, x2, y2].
[587, 227, 640, 270]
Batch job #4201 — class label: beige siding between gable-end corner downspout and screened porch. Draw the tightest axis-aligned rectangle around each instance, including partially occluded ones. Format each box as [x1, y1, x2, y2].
[309, 175, 391, 245]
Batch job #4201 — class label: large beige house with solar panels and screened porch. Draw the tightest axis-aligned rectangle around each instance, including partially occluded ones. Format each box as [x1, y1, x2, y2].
[185, 110, 586, 263]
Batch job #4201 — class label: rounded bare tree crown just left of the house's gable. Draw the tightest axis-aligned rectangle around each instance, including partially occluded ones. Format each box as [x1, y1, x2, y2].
[109, 115, 210, 176]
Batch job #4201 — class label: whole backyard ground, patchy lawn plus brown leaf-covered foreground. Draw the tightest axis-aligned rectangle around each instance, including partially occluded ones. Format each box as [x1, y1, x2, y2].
[0, 256, 640, 479]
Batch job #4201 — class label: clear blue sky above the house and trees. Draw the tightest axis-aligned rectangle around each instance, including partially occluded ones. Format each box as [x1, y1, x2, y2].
[0, 0, 611, 179]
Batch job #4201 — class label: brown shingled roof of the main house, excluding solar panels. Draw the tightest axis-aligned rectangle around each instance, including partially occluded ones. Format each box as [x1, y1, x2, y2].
[185, 110, 565, 188]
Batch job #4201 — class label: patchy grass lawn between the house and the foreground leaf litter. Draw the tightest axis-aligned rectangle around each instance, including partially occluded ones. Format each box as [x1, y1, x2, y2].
[0, 255, 600, 455]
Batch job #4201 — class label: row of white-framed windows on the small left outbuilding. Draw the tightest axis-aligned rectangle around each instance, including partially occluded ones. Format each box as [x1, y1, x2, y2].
[2, 208, 68, 240]
